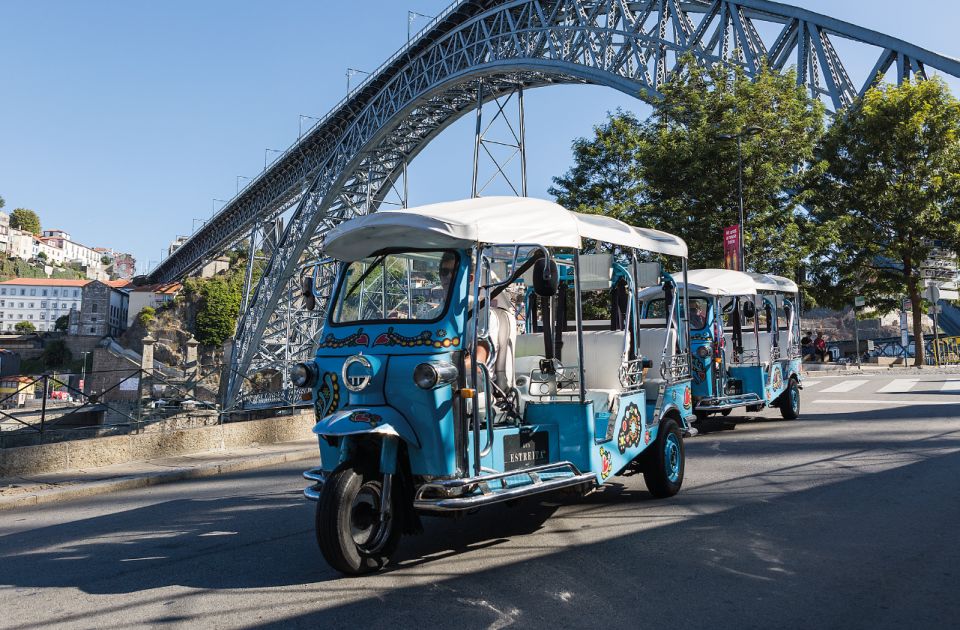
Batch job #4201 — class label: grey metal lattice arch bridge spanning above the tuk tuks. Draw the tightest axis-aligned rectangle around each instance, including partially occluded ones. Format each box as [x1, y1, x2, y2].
[144, 0, 960, 407]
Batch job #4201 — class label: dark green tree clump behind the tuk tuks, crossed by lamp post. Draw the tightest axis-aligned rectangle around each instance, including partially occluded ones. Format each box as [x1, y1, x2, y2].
[550, 58, 823, 276]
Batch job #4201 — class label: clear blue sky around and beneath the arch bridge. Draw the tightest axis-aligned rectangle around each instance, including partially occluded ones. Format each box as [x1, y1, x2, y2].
[0, 0, 960, 271]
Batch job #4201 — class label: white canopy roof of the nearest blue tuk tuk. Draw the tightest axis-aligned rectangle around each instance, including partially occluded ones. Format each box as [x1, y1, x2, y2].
[324, 197, 687, 261]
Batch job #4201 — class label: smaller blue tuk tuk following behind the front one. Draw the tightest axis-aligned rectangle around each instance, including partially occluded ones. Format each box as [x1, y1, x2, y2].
[639, 269, 802, 420]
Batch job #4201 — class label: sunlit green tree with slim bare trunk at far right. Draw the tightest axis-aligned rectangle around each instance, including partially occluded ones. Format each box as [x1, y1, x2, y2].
[812, 79, 960, 365]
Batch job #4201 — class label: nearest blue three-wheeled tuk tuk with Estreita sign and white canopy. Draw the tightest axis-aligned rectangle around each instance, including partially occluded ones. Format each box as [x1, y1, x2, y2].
[292, 197, 693, 574]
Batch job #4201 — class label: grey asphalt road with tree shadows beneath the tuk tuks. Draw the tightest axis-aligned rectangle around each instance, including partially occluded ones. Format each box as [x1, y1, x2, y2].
[0, 375, 960, 629]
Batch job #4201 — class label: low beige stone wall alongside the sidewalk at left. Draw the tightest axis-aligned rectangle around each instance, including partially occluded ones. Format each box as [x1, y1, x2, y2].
[0, 411, 314, 477]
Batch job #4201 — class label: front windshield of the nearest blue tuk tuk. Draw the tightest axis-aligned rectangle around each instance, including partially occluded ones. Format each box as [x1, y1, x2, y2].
[333, 251, 458, 324]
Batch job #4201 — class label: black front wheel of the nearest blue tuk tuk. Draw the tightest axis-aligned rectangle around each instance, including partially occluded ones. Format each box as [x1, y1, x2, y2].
[316, 462, 400, 575]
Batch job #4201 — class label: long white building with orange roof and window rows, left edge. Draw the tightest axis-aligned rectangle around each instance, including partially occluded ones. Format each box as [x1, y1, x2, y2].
[0, 278, 89, 332]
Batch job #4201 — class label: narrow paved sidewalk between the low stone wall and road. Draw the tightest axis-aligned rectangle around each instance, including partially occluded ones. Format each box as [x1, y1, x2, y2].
[0, 439, 319, 511]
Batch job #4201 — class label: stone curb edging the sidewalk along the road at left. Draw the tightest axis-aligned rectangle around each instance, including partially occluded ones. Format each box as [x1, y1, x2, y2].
[0, 448, 317, 512]
